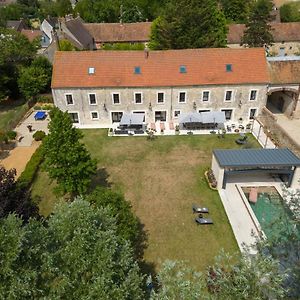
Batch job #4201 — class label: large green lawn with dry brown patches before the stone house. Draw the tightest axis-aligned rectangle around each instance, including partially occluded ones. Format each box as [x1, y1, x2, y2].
[32, 129, 258, 270]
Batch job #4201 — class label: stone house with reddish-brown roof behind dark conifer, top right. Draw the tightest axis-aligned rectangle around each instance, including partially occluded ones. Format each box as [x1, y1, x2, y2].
[227, 22, 300, 56]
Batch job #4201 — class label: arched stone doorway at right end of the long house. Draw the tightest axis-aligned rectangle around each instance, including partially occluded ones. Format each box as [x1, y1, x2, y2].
[266, 89, 297, 116]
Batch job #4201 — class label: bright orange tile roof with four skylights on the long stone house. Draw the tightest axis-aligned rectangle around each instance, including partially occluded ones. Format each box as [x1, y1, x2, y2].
[52, 48, 269, 88]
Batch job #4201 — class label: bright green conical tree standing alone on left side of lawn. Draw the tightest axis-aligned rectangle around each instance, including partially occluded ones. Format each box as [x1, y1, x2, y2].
[43, 108, 97, 195]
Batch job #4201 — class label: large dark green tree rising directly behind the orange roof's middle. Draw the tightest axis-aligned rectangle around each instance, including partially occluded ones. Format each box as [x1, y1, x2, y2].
[149, 0, 227, 50]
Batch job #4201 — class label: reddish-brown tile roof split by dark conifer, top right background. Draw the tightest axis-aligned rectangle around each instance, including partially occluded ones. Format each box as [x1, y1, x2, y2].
[227, 22, 300, 44]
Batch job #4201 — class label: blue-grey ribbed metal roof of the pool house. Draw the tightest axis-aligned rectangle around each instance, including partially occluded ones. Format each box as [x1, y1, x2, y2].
[213, 148, 300, 167]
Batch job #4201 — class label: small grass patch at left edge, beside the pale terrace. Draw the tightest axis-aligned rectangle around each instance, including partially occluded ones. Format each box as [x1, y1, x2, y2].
[0, 100, 28, 131]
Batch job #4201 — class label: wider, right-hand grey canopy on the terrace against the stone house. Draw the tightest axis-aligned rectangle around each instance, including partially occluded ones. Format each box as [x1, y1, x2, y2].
[179, 111, 225, 124]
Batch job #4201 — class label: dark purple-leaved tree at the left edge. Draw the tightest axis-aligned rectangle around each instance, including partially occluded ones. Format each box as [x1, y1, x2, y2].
[0, 166, 38, 221]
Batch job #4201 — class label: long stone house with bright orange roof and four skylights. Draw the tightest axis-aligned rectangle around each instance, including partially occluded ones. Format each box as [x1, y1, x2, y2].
[52, 48, 270, 128]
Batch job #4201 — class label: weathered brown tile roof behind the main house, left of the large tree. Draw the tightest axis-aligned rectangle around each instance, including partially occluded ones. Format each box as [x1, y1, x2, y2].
[84, 22, 152, 43]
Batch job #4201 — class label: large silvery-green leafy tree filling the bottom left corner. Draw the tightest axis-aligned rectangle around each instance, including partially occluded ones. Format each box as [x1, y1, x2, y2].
[0, 199, 143, 299]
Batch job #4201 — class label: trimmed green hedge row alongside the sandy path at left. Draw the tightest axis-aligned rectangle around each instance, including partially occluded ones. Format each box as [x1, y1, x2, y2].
[17, 145, 44, 189]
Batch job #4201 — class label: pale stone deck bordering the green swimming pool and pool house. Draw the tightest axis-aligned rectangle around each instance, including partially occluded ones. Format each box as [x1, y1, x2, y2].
[219, 176, 282, 254]
